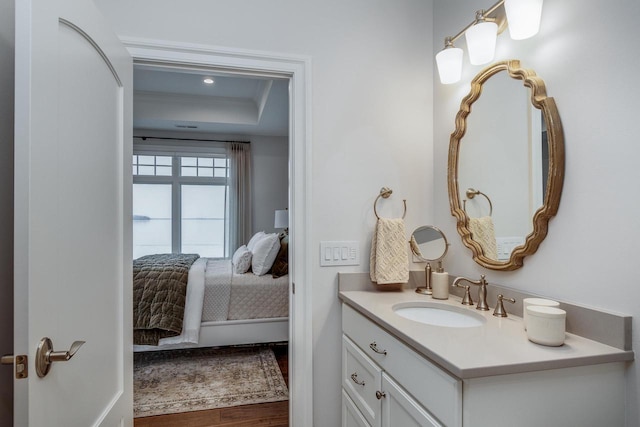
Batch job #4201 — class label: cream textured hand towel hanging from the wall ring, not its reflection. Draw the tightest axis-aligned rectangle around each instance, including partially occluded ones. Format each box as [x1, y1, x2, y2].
[369, 218, 409, 285]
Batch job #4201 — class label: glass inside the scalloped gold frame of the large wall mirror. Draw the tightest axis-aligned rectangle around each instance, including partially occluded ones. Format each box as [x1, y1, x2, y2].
[458, 73, 549, 261]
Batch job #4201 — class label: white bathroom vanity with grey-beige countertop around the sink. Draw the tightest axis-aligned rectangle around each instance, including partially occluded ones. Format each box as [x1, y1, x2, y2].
[339, 288, 633, 427]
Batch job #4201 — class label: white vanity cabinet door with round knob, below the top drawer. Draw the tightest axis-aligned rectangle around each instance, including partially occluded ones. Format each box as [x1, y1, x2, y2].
[382, 372, 442, 427]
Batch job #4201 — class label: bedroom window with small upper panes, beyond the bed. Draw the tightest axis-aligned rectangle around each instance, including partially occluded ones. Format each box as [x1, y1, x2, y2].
[133, 153, 230, 258]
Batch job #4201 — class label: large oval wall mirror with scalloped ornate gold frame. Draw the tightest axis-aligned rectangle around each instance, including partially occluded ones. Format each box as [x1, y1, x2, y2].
[448, 60, 564, 270]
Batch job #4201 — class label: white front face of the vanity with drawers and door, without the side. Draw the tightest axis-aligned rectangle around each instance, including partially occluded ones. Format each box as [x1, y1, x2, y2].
[342, 305, 462, 427]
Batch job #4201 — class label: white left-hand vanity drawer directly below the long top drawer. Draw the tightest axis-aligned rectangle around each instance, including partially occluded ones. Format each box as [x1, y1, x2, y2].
[342, 335, 382, 427]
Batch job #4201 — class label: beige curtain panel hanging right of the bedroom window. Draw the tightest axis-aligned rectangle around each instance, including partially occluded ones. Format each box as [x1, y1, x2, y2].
[227, 142, 252, 256]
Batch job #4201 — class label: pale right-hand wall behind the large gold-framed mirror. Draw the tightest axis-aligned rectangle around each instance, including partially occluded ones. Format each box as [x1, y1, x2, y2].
[434, 0, 640, 427]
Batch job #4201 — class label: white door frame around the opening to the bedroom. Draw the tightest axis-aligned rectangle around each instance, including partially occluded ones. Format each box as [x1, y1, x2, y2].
[120, 37, 313, 426]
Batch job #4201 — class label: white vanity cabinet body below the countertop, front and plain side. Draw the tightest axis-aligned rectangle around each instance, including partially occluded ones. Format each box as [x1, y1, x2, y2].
[342, 304, 625, 427]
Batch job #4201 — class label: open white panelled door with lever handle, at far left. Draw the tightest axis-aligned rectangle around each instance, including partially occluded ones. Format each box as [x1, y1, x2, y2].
[14, 0, 132, 427]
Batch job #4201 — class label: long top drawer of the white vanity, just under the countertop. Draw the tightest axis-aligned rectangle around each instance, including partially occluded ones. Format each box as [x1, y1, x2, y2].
[342, 304, 462, 427]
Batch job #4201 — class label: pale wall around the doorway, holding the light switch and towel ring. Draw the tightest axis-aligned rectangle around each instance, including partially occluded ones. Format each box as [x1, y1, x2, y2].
[96, 0, 434, 427]
